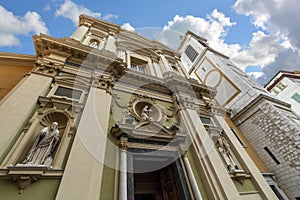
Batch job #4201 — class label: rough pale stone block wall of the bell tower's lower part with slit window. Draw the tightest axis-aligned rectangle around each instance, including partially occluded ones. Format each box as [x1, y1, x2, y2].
[235, 100, 300, 198]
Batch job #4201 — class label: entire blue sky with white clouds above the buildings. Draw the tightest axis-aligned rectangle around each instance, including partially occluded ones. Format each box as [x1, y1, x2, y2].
[0, 0, 300, 84]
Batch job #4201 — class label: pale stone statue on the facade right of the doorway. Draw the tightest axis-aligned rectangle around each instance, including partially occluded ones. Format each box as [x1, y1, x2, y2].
[217, 135, 239, 172]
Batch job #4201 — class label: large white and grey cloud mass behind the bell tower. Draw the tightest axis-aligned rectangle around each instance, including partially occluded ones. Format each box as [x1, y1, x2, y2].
[152, 4, 300, 84]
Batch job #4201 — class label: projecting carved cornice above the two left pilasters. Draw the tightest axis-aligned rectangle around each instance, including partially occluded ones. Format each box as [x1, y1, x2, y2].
[34, 34, 126, 82]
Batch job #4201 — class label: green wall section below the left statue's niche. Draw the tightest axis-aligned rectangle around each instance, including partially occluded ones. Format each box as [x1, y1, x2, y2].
[0, 179, 60, 200]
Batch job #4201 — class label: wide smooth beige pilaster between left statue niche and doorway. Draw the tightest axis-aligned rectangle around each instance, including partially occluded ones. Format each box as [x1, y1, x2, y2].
[57, 87, 111, 199]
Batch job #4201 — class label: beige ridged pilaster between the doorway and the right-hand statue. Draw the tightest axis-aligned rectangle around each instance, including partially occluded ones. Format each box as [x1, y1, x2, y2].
[180, 108, 240, 199]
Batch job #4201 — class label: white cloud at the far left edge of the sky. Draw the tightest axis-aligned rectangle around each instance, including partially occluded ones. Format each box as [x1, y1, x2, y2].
[0, 6, 48, 46]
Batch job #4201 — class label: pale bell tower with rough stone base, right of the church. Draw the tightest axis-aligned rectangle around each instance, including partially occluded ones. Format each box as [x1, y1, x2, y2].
[178, 32, 300, 199]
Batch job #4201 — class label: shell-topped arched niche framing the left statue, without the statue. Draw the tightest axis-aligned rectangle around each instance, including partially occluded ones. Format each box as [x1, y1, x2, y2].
[1, 103, 77, 169]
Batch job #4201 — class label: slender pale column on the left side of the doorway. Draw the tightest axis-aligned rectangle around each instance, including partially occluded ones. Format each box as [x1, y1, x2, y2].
[119, 138, 127, 200]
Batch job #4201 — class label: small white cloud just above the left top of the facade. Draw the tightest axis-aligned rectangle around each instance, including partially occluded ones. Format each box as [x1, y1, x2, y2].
[55, 0, 118, 25]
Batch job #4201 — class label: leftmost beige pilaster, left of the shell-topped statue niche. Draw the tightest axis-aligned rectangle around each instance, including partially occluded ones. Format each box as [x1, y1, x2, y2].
[0, 74, 52, 160]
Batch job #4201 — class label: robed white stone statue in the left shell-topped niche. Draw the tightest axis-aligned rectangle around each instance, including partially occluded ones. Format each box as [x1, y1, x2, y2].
[23, 122, 59, 166]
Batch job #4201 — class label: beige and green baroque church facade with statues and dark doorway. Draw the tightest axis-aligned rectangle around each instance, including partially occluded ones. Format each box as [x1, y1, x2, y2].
[0, 15, 290, 200]
